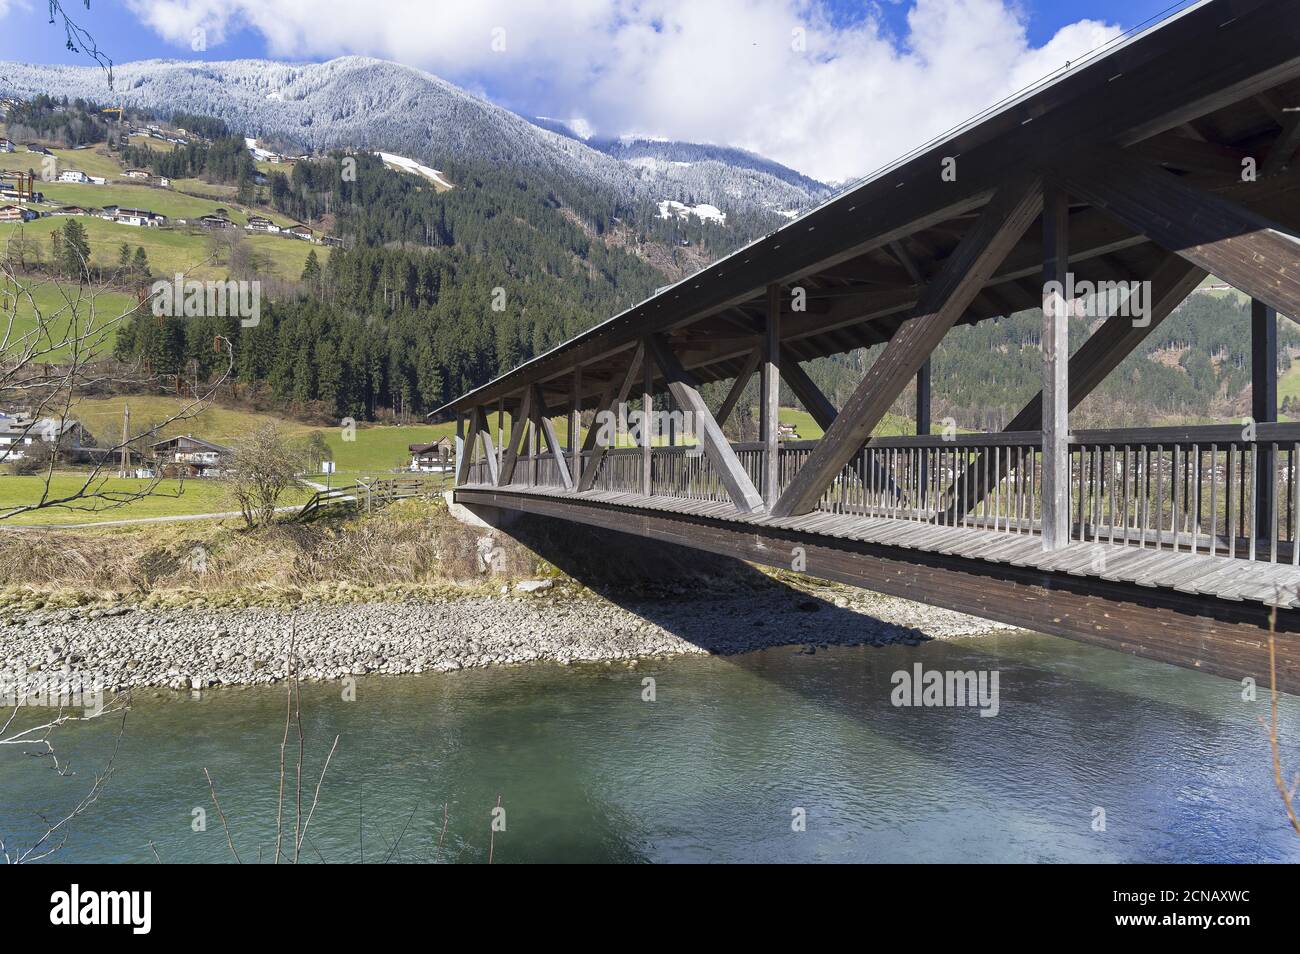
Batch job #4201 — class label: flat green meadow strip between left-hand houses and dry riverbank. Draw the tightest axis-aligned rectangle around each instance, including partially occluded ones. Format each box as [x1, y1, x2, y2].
[0, 472, 313, 526]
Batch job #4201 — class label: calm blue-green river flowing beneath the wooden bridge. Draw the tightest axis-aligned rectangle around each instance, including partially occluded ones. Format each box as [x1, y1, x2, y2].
[0, 633, 1300, 863]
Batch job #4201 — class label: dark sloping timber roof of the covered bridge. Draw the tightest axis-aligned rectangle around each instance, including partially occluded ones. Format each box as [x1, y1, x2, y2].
[434, 0, 1300, 415]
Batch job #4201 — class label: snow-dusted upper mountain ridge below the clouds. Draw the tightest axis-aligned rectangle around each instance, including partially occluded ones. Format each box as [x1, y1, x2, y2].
[0, 56, 827, 213]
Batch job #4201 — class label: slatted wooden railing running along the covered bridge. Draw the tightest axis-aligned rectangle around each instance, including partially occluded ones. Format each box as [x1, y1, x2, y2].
[468, 424, 1300, 564]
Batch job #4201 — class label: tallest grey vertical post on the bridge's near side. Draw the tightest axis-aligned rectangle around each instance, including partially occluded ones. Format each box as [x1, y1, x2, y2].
[1043, 186, 1070, 550]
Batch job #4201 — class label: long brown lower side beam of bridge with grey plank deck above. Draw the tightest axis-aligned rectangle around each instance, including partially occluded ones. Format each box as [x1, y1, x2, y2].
[455, 486, 1300, 693]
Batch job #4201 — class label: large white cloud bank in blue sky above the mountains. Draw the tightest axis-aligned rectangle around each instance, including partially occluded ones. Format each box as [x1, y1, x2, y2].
[119, 0, 1119, 179]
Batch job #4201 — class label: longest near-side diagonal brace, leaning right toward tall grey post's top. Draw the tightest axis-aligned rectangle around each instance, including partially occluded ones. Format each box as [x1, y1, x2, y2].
[772, 178, 1043, 517]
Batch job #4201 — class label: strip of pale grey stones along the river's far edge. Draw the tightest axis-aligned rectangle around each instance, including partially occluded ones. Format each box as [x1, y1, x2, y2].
[0, 582, 1002, 689]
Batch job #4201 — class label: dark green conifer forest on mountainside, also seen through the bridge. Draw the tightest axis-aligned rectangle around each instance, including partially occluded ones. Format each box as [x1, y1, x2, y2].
[109, 124, 1300, 429]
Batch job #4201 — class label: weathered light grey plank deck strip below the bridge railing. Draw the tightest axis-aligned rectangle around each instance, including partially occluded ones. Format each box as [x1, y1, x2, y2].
[462, 483, 1300, 608]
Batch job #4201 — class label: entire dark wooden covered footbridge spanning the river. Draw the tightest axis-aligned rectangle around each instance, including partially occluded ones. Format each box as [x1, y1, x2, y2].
[436, 0, 1300, 691]
